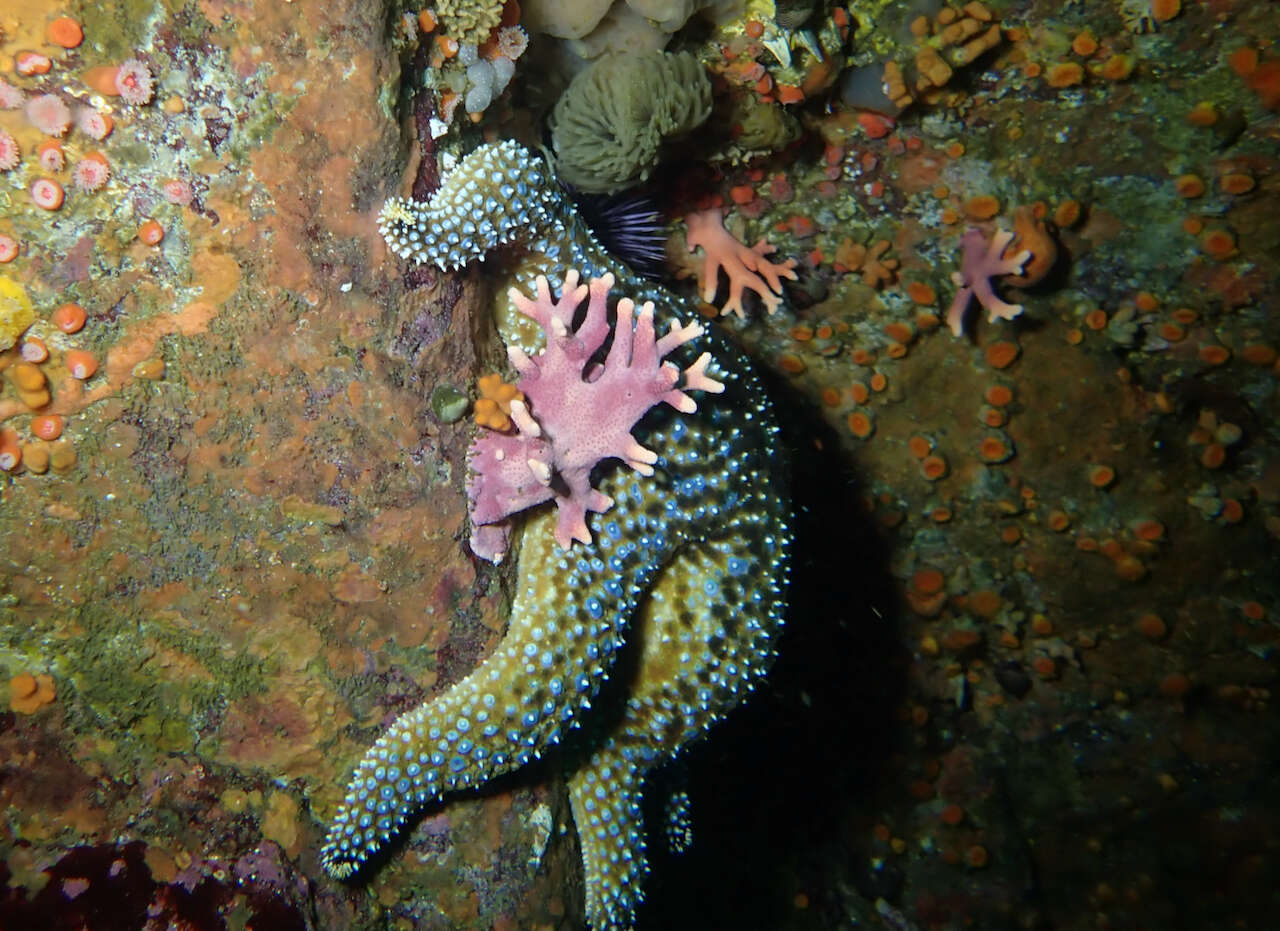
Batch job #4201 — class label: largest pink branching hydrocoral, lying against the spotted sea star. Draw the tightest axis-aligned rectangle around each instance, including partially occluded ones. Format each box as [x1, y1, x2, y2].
[467, 270, 724, 562]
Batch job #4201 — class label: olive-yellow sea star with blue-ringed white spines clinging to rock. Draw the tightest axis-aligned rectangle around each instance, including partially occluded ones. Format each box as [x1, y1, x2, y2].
[321, 142, 791, 931]
